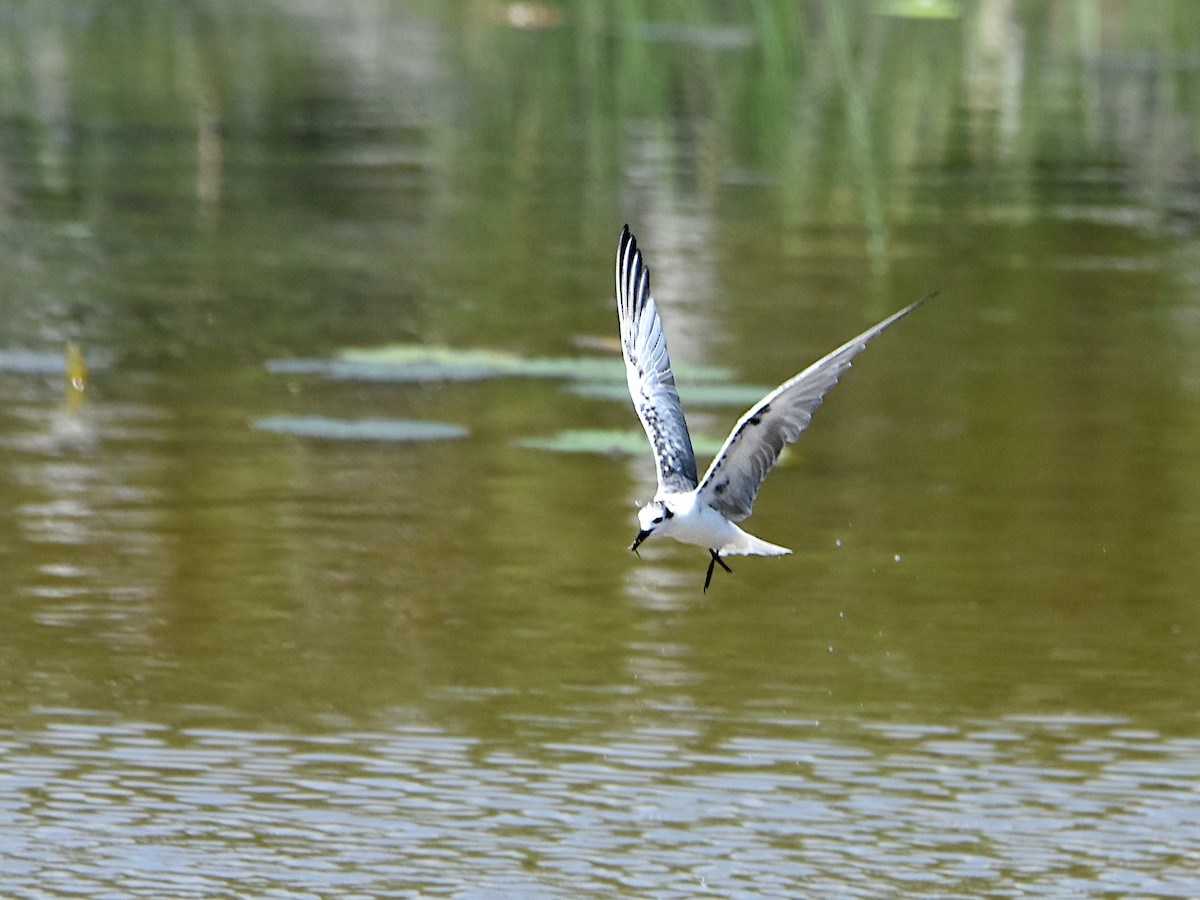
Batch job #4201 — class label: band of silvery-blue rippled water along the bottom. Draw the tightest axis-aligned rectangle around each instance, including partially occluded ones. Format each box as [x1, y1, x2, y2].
[0, 716, 1200, 898]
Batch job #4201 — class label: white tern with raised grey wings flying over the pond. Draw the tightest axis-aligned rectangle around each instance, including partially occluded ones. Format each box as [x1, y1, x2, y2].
[617, 224, 937, 590]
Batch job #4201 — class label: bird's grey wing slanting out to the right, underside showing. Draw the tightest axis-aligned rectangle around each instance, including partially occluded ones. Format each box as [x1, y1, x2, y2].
[700, 292, 937, 522]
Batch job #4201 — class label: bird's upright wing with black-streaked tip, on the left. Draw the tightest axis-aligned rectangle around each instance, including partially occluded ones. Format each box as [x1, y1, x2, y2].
[617, 226, 697, 491]
